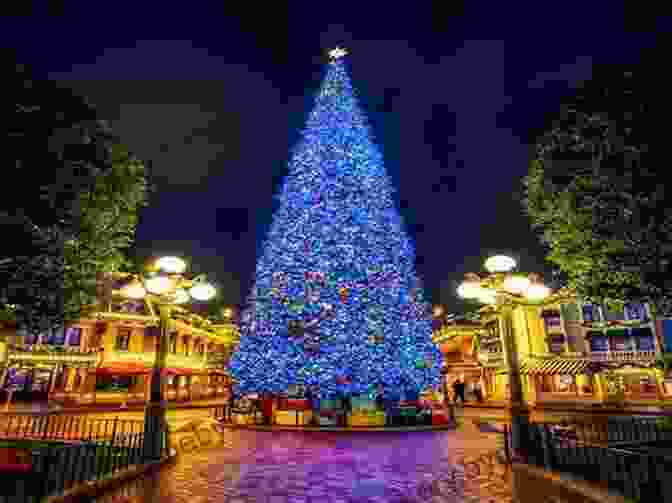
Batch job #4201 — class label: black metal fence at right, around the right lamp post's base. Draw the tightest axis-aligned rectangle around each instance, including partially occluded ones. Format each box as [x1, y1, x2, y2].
[504, 418, 672, 502]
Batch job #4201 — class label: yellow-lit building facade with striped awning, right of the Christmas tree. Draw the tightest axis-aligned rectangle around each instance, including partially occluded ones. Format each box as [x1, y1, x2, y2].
[434, 291, 672, 412]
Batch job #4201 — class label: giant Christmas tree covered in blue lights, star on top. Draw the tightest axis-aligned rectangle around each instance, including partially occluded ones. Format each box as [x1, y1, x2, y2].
[230, 50, 442, 397]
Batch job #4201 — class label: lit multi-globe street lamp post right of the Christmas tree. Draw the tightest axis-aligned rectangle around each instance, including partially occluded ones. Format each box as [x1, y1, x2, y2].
[458, 255, 550, 459]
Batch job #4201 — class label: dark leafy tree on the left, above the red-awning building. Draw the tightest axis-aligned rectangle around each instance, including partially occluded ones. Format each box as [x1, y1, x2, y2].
[0, 54, 147, 332]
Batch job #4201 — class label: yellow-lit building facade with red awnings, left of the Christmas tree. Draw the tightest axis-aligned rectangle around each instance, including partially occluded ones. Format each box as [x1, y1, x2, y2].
[0, 276, 239, 406]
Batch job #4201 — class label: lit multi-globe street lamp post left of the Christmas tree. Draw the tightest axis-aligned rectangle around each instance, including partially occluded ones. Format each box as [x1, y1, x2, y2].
[122, 257, 217, 460]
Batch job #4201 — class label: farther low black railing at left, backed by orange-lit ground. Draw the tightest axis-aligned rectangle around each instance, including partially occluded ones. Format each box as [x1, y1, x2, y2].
[0, 414, 144, 441]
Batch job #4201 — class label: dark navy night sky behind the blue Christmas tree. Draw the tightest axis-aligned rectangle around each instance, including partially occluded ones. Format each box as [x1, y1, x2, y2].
[0, 1, 667, 316]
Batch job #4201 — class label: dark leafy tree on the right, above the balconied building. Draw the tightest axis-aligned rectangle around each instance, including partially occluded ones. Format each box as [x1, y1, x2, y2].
[523, 65, 672, 314]
